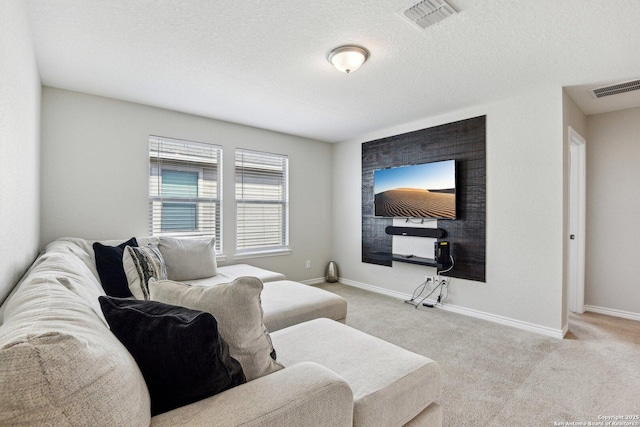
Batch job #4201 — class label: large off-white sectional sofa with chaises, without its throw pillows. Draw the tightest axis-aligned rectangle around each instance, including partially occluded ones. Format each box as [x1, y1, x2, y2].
[0, 238, 442, 426]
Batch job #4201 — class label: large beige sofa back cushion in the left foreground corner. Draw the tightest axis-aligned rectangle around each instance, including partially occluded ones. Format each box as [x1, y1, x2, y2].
[0, 276, 150, 426]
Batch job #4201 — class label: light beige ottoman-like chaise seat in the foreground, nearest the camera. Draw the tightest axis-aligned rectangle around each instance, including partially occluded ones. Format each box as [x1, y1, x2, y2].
[272, 319, 442, 426]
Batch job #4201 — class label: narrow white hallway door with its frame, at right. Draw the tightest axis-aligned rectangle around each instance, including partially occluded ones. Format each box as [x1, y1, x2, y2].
[568, 126, 587, 313]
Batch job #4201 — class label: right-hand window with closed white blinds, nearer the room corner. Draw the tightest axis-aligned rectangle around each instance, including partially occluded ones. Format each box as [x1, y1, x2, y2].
[235, 149, 289, 253]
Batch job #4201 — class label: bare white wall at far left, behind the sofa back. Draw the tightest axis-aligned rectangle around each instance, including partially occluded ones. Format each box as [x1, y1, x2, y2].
[0, 0, 41, 302]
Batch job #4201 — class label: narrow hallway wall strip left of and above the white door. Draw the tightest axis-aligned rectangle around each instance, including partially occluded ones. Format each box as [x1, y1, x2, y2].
[562, 90, 587, 327]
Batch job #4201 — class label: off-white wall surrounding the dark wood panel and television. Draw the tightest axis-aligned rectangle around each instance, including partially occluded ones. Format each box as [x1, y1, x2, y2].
[333, 88, 564, 336]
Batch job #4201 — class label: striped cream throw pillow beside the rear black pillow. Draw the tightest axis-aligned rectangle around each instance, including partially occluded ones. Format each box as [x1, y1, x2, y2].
[122, 245, 167, 300]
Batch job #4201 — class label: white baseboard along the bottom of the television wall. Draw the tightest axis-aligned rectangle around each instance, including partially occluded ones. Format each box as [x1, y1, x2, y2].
[339, 278, 568, 339]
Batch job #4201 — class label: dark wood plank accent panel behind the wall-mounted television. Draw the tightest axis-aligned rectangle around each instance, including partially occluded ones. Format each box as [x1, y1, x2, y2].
[362, 116, 486, 282]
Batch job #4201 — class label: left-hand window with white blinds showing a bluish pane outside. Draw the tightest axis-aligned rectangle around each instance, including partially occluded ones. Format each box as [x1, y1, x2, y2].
[149, 136, 222, 253]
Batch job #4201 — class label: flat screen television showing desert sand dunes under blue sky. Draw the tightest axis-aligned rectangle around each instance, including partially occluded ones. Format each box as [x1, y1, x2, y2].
[373, 160, 456, 219]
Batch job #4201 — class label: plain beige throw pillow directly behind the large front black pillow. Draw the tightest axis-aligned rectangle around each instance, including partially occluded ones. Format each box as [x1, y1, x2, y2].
[149, 277, 283, 381]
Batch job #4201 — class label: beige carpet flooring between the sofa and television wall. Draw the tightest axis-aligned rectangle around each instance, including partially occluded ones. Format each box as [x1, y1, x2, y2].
[317, 283, 640, 426]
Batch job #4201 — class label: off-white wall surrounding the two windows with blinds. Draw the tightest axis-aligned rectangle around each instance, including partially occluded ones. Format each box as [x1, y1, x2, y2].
[41, 87, 332, 280]
